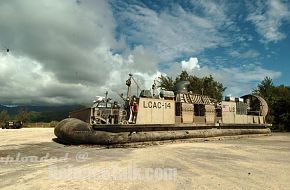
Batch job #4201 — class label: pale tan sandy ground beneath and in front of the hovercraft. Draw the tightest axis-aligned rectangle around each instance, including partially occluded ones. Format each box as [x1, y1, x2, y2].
[0, 128, 290, 190]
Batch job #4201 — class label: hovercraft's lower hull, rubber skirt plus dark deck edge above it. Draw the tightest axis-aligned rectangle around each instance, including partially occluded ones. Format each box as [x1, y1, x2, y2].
[54, 118, 271, 145]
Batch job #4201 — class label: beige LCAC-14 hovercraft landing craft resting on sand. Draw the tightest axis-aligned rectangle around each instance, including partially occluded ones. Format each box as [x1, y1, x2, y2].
[54, 75, 271, 145]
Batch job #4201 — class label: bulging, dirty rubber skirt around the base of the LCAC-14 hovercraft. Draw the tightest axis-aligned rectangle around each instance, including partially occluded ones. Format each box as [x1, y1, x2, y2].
[54, 118, 271, 145]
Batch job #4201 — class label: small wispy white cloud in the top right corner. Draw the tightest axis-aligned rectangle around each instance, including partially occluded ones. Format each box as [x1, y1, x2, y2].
[247, 0, 290, 42]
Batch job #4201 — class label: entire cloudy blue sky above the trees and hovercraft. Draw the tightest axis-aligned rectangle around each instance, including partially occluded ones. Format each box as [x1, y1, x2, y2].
[0, 0, 290, 105]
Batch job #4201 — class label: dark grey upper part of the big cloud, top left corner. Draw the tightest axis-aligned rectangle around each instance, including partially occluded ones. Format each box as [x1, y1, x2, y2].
[0, 0, 115, 83]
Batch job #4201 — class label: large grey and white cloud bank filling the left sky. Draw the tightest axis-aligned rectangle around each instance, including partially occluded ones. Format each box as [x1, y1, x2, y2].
[0, 0, 158, 104]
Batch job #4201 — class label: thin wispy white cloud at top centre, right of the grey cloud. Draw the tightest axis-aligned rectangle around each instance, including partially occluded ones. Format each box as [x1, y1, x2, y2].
[112, 1, 231, 61]
